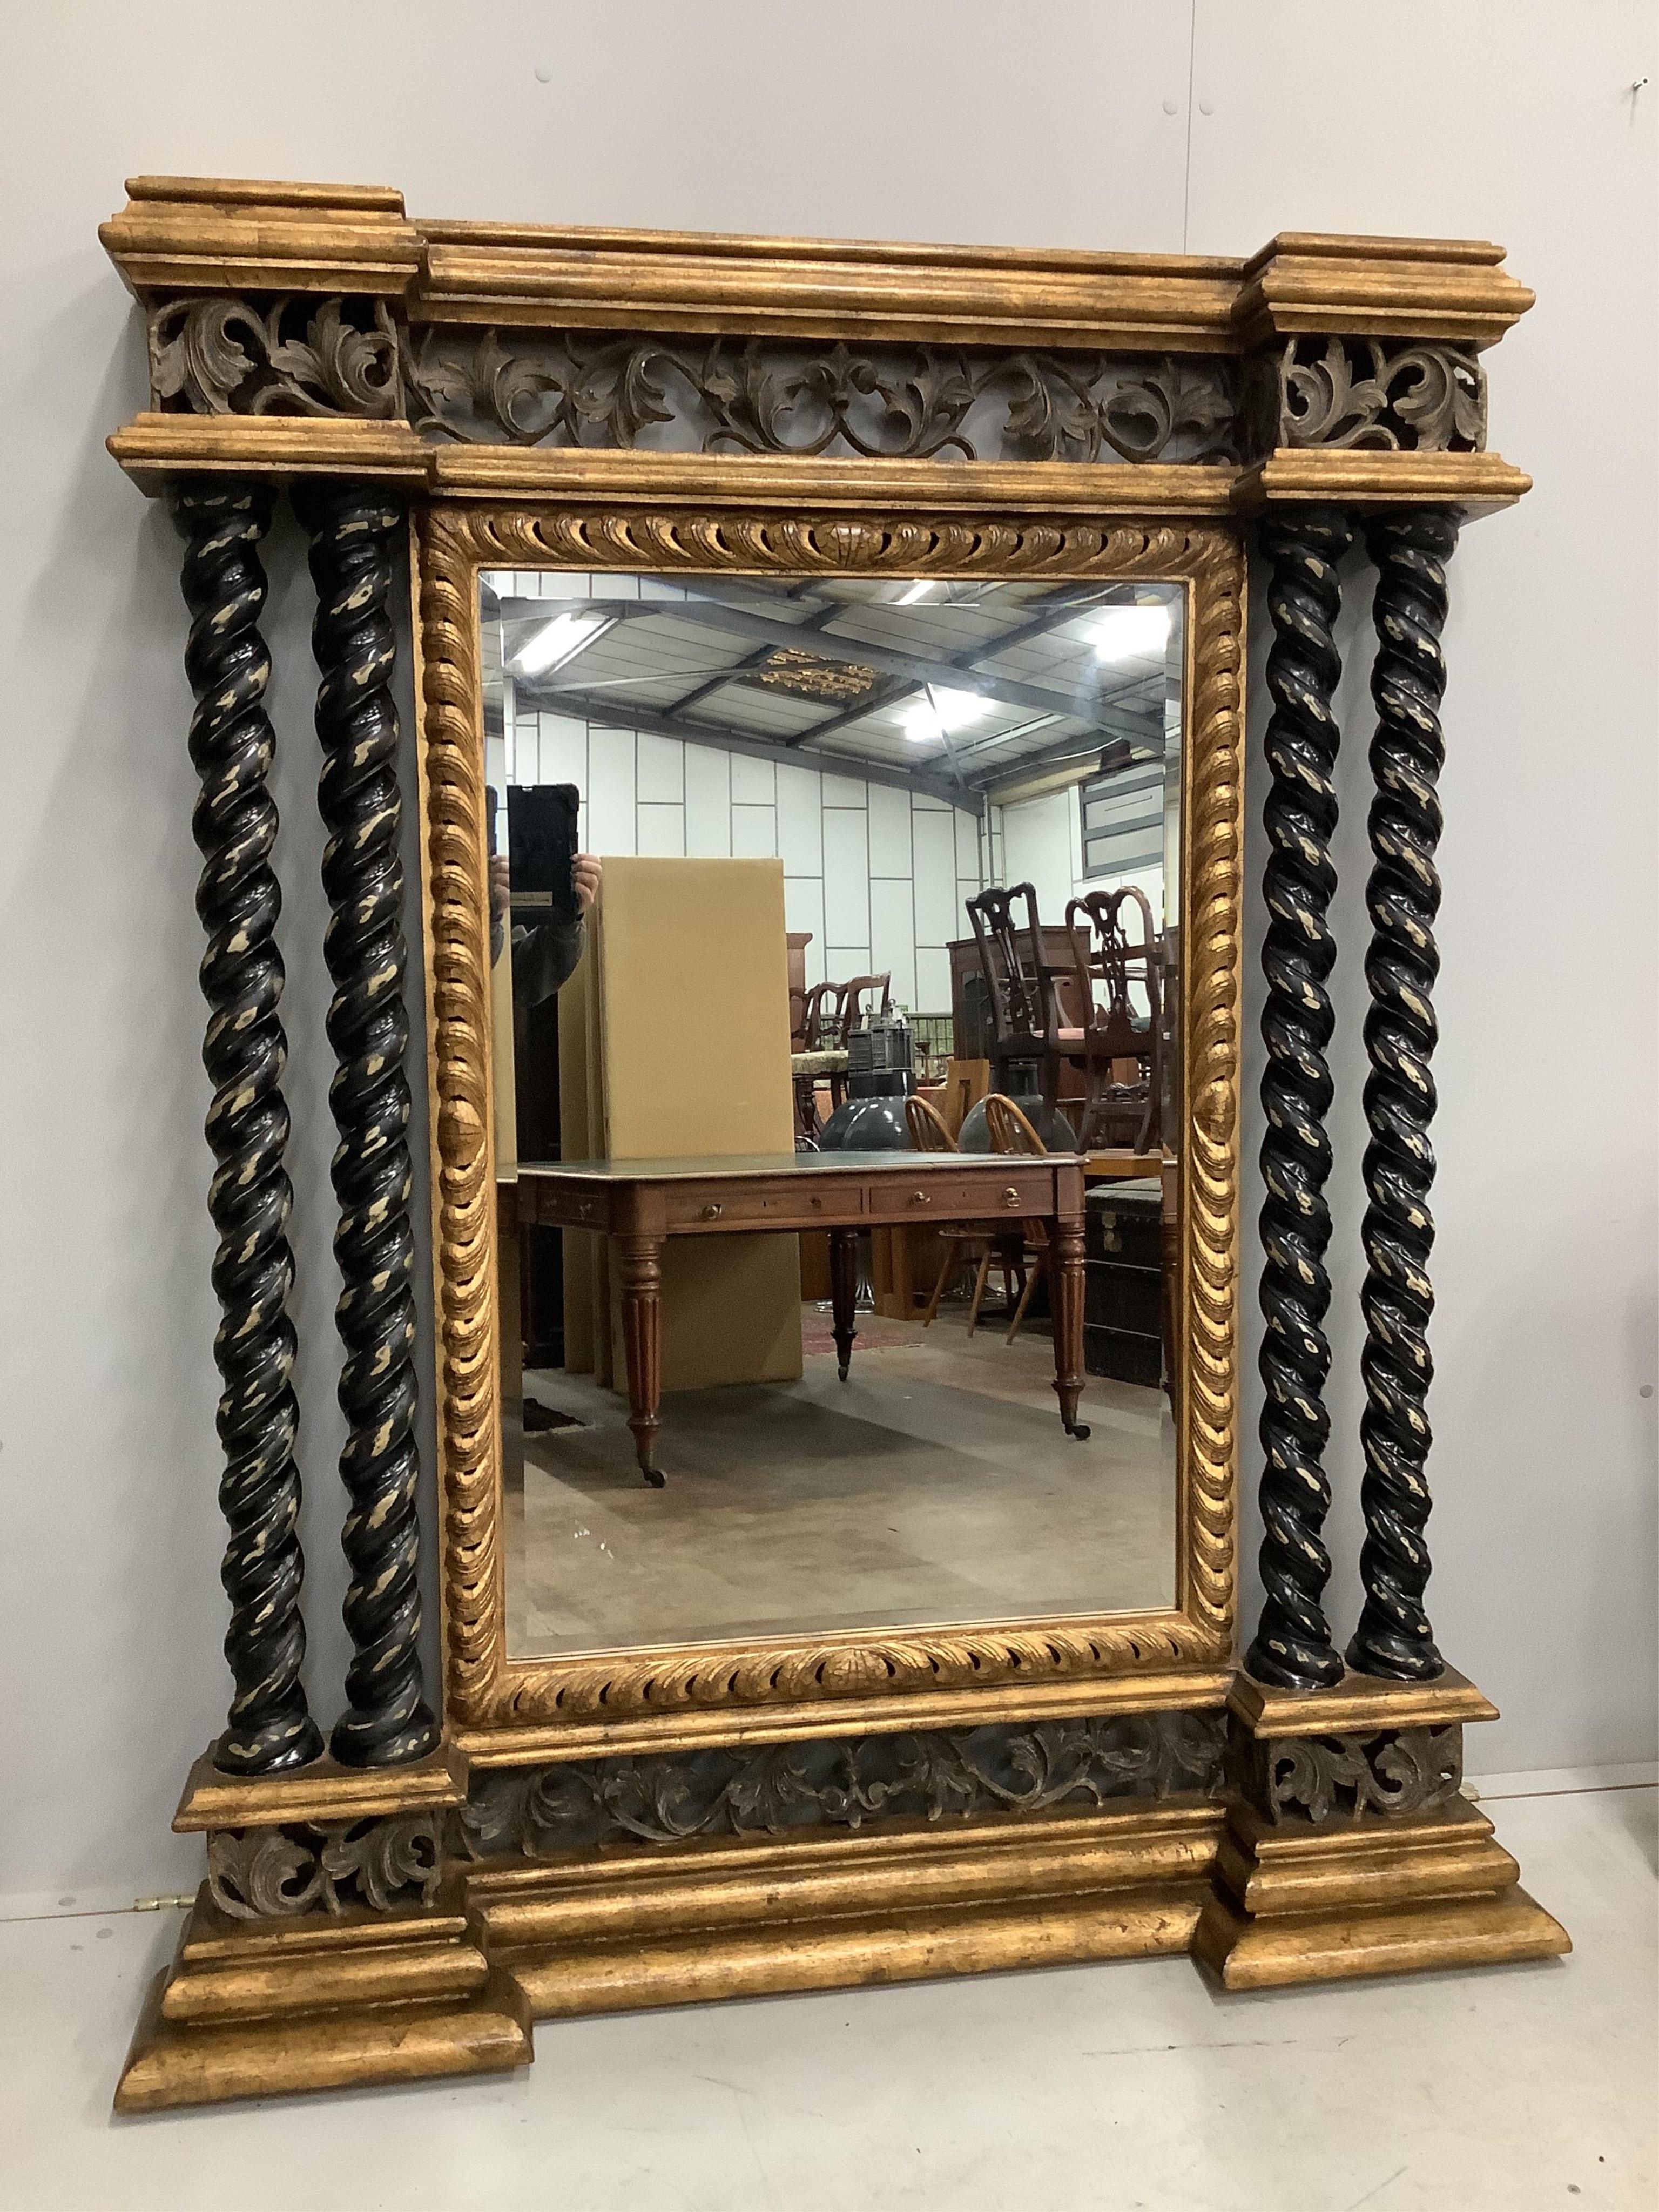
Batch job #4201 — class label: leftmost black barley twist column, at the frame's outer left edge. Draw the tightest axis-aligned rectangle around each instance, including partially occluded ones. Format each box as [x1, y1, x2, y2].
[170, 480, 323, 1774]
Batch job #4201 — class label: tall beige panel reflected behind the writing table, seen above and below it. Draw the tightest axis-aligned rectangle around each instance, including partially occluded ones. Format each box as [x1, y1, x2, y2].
[595, 858, 801, 1389]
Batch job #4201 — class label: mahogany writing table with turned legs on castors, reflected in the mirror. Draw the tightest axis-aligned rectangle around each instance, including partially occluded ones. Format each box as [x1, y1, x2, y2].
[517, 1152, 1088, 1484]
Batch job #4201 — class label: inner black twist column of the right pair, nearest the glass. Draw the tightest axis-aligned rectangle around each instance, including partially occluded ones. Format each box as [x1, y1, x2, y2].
[1245, 507, 1352, 1690]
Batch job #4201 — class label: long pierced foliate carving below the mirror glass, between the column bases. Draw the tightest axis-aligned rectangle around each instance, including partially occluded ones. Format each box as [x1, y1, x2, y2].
[456, 1712, 1225, 1858]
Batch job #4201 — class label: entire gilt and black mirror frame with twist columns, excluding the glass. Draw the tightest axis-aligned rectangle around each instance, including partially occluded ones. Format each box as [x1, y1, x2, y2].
[102, 177, 1566, 2110]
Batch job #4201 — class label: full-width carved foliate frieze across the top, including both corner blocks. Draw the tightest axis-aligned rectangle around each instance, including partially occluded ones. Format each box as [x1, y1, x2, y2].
[148, 305, 1487, 462]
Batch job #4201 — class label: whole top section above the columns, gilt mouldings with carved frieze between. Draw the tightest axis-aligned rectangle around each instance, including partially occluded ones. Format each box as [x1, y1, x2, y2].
[99, 177, 1533, 515]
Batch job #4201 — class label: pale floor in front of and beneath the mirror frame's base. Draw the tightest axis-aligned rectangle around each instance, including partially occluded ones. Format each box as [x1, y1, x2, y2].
[0, 1790, 1659, 2212]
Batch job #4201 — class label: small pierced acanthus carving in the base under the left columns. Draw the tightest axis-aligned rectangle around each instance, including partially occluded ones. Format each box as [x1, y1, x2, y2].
[208, 1812, 444, 1920]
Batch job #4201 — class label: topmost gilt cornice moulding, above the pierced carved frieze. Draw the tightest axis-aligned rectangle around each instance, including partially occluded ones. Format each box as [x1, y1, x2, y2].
[99, 177, 1533, 354]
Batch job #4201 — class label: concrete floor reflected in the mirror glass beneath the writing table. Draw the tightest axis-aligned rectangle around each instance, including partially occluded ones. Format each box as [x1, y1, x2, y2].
[504, 1312, 1175, 1657]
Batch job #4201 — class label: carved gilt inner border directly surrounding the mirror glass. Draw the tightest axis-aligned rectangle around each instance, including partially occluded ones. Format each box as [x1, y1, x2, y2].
[418, 480, 1243, 1761]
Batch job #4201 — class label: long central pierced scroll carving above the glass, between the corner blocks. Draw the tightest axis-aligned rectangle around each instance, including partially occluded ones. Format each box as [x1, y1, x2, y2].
[402, 329, 1239, 462]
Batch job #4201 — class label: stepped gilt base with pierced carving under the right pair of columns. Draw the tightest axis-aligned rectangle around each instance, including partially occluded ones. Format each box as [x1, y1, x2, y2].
[1192, 1670, 1573, 1988]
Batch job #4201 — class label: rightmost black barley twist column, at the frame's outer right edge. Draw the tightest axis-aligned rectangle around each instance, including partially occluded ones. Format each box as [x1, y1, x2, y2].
[1347, 509, 1458, 1681]
